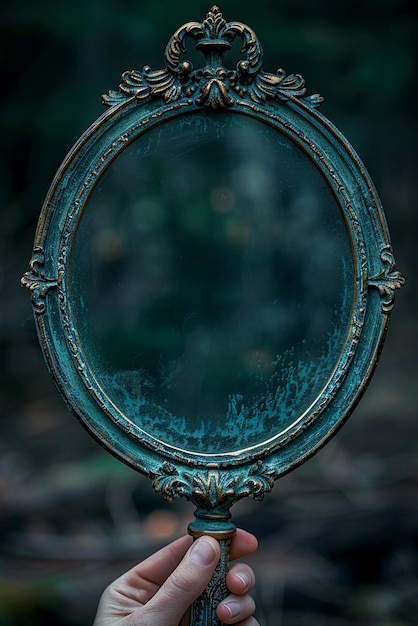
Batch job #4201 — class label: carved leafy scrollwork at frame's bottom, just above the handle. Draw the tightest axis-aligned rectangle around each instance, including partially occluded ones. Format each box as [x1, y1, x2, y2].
[151, 461, 278, 509]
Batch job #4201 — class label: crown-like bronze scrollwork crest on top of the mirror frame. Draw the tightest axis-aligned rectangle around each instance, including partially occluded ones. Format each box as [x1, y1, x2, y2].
[102, 6, 323, 110]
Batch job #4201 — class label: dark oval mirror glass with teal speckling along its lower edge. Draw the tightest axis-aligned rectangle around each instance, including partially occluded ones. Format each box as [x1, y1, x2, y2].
[68, 112, 354, 454]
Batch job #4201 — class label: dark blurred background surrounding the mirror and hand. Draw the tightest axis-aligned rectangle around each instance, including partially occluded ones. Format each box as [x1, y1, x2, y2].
[0, 0, 418, 626]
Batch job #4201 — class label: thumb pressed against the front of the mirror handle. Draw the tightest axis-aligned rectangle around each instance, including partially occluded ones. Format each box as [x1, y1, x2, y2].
[141, 536, 220, 626]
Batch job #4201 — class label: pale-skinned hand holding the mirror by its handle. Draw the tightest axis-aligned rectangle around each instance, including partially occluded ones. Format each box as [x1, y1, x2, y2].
[93, 529, 259, 626]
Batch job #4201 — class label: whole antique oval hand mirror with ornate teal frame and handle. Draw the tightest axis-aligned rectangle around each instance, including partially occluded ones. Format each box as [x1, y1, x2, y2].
[22, 7, 403, 625]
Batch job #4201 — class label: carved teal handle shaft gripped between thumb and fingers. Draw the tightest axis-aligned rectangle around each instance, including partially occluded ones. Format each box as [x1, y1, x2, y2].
[190, 538, 231, 626]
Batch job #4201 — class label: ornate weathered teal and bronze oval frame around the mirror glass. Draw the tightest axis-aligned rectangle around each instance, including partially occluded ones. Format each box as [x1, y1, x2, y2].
[22, 7, 404, 624]
